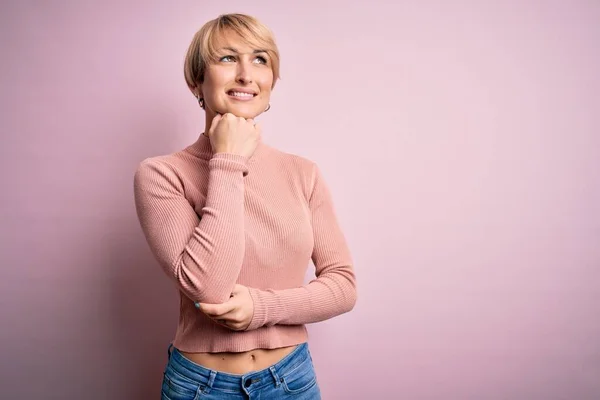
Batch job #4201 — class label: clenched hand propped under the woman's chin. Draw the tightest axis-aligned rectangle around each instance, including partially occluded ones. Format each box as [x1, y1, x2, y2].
[208, 113, 261, 158]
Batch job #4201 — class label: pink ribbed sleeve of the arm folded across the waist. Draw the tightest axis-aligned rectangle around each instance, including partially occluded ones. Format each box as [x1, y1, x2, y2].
[246, 165, 357, 330]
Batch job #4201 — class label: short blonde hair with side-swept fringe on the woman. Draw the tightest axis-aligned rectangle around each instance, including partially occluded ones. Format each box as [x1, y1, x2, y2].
[183, 14, 280, 94]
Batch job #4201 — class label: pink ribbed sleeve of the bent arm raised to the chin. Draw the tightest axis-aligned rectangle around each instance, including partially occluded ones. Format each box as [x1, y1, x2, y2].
[134, 153, 248, 303]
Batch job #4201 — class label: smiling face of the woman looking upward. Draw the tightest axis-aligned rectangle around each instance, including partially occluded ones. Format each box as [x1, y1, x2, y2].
[199, 33, 273, 118]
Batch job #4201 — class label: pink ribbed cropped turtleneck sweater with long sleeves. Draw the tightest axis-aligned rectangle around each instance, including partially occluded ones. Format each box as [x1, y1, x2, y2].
[134, 135, 356, 352]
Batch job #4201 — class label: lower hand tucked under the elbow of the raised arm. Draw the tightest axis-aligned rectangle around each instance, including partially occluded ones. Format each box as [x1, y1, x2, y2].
[196, 284, 254, 331]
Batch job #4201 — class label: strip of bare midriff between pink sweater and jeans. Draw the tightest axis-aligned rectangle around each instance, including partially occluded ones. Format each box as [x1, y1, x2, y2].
[180, 346, 297, 375]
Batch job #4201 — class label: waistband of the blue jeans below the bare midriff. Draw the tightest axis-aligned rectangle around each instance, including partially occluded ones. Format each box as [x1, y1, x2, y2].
[169, 342, 311, 393]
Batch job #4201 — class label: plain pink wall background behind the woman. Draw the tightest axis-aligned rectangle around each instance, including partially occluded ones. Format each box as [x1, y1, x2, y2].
[0, 0, 600, 400]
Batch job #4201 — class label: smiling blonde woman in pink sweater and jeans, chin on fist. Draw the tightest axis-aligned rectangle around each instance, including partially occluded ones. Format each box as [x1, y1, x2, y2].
[134, 14, 356, 400]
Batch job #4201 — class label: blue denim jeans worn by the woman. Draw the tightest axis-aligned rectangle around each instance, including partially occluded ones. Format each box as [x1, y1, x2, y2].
[162, 343, 321, 400]
